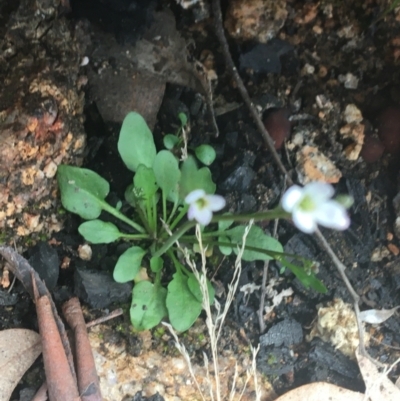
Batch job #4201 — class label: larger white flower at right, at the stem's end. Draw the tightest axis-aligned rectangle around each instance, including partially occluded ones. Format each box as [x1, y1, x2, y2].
[282, 182, 350, 233]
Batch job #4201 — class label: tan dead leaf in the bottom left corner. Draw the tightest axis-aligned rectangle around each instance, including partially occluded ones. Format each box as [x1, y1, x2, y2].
[0, 329, 42, 401]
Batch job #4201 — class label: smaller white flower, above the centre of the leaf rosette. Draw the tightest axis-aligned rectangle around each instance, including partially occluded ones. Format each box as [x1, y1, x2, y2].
[185, 189, 226, 226]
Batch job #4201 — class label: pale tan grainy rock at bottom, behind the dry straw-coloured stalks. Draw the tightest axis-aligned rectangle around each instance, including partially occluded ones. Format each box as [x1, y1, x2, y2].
[89, 325, 276, 401]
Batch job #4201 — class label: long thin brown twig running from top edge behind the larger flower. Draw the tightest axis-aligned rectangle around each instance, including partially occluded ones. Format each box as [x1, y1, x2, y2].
[212, 0, 386, 367]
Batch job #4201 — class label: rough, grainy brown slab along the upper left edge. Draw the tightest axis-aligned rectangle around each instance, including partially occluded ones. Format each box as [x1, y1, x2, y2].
[0, 0, 85, 243]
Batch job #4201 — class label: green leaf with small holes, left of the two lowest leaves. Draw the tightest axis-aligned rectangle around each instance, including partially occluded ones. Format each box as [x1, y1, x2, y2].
[129, 281, 168, 330]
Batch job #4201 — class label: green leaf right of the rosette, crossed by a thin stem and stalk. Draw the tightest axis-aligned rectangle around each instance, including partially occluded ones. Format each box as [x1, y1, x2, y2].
[225, 225, 283, 262]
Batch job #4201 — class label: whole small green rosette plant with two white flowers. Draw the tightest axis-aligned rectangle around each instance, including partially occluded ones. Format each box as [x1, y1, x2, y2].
[57, 112, 347, 331]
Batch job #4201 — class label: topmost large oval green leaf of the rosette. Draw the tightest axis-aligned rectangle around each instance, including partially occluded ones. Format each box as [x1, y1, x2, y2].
[118, 112, 156, 171]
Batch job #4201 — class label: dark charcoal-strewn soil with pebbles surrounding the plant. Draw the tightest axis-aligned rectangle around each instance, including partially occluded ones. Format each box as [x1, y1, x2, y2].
[0, 0, 400, 400]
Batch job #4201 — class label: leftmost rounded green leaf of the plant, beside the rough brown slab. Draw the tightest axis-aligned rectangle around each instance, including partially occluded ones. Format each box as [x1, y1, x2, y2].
[57, 164, 110, 220]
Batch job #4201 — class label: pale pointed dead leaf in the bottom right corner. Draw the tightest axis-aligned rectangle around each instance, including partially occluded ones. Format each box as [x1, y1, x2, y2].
[356, 349, 400, 401]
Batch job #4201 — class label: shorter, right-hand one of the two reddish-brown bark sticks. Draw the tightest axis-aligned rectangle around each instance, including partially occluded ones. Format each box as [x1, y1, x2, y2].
[63, 298, 102, 401]
